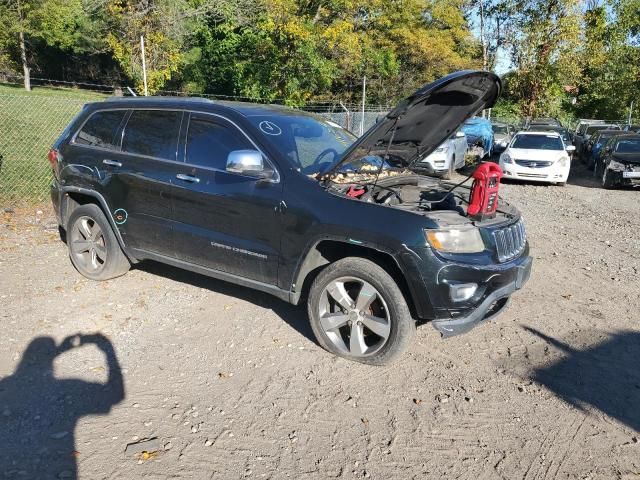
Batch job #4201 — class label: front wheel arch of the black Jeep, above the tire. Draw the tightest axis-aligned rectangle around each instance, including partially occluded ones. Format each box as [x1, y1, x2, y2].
[290, 239, 417, 318]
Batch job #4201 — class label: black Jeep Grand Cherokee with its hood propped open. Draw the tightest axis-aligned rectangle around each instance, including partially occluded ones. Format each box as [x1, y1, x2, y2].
[49, 71, 531, 364]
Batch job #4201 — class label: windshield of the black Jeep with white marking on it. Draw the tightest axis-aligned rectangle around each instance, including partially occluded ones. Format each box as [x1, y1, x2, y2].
[247, 114, 356, 175]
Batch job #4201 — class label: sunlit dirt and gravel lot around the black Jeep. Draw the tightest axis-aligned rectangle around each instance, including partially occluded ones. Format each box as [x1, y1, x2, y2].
[0, 163, 640, 480]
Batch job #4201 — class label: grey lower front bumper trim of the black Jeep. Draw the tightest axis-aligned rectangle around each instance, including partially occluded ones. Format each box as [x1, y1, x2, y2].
[431, 257, 532, 337]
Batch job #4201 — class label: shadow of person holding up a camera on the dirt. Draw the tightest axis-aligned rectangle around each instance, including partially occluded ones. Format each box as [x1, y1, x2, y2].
[0, 334, 125, 479]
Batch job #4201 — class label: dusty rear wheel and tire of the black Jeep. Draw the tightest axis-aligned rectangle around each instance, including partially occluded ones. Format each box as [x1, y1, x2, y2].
[67, 204, 131, 281]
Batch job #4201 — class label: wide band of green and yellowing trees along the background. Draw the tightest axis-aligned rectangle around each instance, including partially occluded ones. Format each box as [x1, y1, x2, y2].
[0, 0, 640, 118]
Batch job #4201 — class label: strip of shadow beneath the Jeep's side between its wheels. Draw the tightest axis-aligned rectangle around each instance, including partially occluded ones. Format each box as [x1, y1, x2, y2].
[136, 261, 317, 345]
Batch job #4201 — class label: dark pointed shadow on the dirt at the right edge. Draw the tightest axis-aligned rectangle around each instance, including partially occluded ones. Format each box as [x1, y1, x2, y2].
[524, 327, 640, 432]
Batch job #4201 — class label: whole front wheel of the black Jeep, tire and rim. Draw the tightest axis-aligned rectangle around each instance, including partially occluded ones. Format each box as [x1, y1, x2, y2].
[307, 257, 416, 365]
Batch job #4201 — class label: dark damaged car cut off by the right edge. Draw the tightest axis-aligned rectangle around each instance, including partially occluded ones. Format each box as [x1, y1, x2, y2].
[599, 135, 640, 188]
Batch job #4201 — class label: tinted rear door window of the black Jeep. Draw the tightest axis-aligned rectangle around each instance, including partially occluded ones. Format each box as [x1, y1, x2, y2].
[122, 110, 182, 160]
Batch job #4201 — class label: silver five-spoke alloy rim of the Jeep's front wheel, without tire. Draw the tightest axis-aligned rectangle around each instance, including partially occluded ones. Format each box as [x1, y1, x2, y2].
[318, 277, 391, 357]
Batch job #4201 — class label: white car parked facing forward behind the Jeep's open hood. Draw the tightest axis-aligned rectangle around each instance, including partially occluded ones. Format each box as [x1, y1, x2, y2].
[500, 131, 575, 185]
